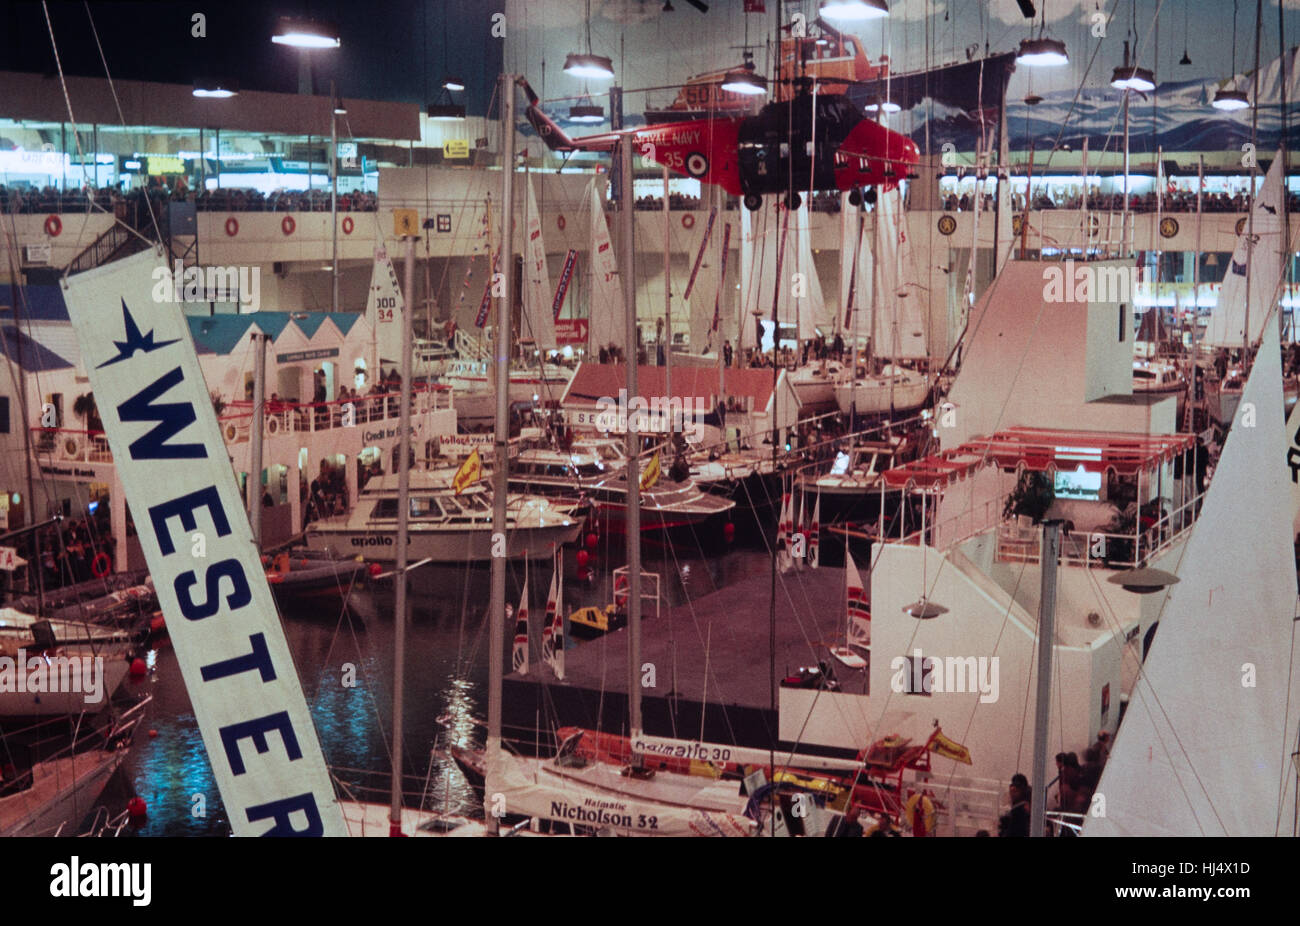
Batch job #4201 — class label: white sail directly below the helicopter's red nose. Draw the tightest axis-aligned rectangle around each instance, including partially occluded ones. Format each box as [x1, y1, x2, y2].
[866, 189, 930, 359]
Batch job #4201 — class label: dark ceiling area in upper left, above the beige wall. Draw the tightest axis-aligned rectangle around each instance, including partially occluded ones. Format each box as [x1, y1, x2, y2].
[0, 0, 503, 114]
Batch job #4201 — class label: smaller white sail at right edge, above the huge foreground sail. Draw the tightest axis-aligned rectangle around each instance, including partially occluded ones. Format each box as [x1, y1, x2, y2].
[1204, 152, 1282, 347]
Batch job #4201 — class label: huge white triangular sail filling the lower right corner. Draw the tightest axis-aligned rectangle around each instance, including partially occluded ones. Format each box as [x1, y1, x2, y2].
[1084, 323, 1300, 836]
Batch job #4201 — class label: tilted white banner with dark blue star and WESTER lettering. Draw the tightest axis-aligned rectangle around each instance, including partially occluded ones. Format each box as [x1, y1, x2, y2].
[64, 251, 347, 836]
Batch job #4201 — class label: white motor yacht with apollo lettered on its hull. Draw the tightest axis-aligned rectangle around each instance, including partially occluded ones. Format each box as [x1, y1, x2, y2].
[307, 470, 582, 563]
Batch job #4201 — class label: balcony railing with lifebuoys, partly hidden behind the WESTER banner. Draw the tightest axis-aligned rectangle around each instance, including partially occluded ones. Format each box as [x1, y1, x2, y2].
[31, 385, 452, 463]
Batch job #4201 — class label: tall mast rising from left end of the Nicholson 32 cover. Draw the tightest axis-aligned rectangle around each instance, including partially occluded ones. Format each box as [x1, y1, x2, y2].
[488, 74, 515, 836]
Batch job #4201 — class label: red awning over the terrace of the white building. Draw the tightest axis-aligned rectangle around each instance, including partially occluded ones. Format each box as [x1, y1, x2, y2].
[883, 428, 1196, 489]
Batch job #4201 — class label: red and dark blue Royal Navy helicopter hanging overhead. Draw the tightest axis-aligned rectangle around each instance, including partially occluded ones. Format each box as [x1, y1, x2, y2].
[519, 78, 920, 211]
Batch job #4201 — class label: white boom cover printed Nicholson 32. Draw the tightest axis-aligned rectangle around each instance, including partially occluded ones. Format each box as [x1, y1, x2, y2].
[486, 748, 757, 836]
